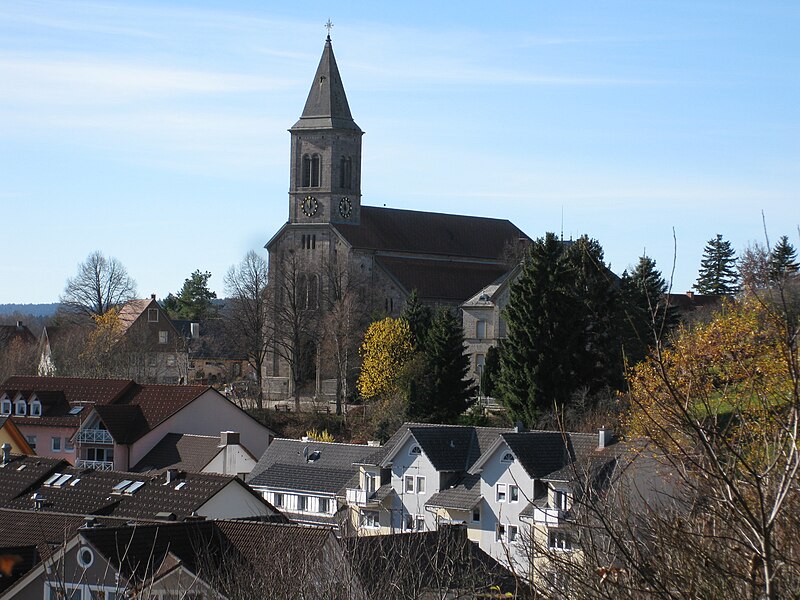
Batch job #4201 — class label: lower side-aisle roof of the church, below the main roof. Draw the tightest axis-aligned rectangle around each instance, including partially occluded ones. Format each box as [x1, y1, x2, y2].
[375, 256, 508, 302]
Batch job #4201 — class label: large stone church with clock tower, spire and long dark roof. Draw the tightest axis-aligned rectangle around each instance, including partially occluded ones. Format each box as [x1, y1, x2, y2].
[263, 35, 529, 399]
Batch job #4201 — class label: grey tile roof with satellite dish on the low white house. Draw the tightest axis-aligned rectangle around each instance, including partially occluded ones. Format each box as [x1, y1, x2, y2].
[247, 438, 375, 494]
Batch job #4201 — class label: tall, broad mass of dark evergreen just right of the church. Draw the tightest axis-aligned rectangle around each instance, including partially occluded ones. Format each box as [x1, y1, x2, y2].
[497, 233, 622, 424]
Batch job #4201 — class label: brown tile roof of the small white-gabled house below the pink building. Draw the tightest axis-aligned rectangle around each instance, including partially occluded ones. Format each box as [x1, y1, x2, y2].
[131, 433, 220, 473]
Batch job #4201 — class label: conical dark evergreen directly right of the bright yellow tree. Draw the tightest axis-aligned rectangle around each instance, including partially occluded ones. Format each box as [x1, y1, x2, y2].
[409, 308, 475, 423]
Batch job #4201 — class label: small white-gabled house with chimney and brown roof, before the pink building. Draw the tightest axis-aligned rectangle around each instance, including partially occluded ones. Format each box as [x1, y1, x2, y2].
[131, 431, 257, 481]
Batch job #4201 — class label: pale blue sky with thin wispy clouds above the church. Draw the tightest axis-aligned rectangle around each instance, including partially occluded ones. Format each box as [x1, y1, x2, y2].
[0, 0, 800, 303]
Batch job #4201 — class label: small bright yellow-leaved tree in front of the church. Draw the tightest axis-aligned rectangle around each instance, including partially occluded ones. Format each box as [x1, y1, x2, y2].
[358, 317, 414, 398]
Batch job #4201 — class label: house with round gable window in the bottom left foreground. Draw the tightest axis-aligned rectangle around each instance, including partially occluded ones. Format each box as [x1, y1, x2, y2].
[4, 520, 344, 600]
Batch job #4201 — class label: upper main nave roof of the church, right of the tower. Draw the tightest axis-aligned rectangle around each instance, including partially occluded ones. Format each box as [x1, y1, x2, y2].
[334, 206, 527, 258]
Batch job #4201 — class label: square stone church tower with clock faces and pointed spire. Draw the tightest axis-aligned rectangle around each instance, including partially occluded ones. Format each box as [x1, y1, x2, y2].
[289, 35, 364, 224]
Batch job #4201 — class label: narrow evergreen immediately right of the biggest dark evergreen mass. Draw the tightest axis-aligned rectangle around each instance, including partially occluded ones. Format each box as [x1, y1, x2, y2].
[620, 256, 678, 365]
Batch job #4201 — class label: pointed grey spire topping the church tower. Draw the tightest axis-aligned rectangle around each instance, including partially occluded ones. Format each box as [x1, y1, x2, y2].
[292, 33, 361, 131]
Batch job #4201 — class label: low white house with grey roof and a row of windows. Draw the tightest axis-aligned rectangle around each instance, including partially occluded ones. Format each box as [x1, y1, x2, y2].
[248, 438, 376, 528]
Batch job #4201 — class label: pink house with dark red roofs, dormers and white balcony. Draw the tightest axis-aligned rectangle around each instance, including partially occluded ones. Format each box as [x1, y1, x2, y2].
[0, 377, 274, 472]
